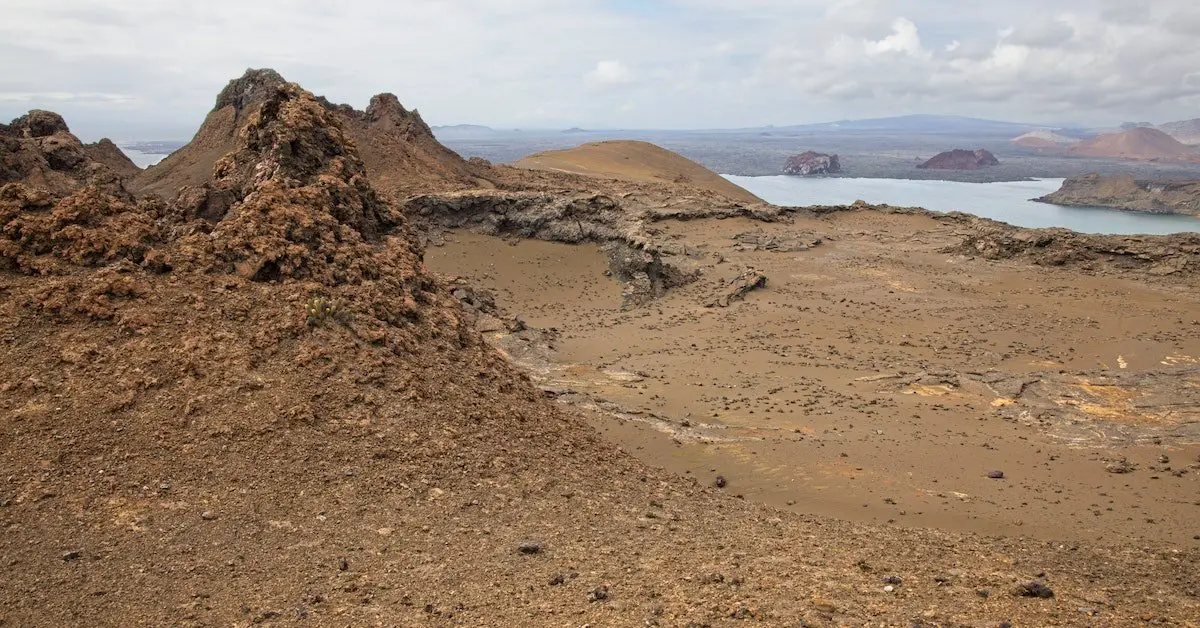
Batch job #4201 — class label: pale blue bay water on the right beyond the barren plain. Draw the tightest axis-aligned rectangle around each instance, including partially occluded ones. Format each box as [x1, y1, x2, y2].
[725, 175, 1200, 234]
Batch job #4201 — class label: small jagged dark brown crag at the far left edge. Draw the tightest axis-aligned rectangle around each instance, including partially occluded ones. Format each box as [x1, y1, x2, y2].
[0, 109, 138, 195]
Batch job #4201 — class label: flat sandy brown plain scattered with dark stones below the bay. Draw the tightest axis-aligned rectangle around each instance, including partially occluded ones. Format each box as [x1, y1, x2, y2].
[426, 211, 1200, 548]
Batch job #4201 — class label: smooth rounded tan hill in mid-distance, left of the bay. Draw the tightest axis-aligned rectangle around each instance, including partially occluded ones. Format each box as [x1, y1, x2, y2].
[516, 139, 762, 203]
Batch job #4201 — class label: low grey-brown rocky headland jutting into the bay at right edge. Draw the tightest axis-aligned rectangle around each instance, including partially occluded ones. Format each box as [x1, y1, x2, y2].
[1034, 174, 1200, 218]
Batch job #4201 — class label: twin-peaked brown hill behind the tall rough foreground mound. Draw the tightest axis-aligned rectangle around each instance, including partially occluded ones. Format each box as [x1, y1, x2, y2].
[134, 70, 487, 198]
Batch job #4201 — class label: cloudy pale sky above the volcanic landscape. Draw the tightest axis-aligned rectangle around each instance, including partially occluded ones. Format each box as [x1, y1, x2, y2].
[0, 0, 1200, 140]
